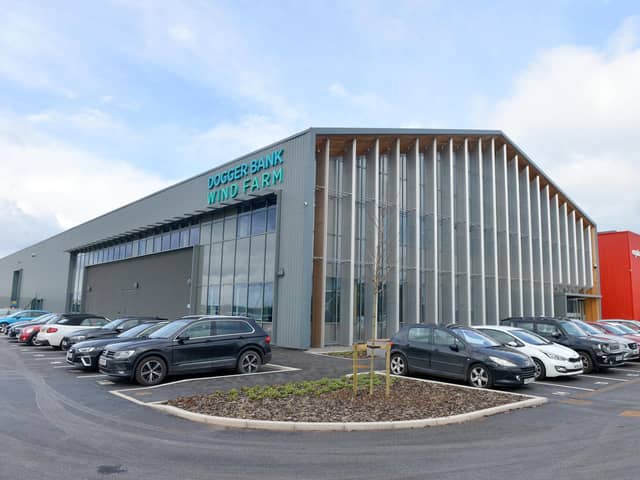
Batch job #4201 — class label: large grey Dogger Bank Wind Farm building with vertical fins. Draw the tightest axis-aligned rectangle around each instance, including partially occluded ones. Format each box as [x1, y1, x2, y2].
[0, 128, 600, 348]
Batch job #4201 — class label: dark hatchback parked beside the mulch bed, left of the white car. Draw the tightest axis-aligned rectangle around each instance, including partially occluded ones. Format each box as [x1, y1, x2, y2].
[391, 324, 536, 388]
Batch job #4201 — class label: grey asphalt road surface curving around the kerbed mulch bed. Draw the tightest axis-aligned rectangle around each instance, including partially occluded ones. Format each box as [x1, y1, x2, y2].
[0, 338, 640, 480]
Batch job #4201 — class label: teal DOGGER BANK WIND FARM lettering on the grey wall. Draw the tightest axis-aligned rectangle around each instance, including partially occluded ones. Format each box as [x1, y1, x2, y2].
[207, 148, 284, 205]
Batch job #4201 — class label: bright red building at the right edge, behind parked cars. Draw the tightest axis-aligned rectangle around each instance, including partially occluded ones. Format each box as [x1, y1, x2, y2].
[598, 231, 640, 320]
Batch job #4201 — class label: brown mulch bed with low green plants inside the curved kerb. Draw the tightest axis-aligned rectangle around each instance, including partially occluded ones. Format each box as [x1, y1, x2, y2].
[167, 379, 526, 422]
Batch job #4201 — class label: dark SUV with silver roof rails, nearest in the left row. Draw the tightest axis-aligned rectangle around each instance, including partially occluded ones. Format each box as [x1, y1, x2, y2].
[98, 316, 271, 385]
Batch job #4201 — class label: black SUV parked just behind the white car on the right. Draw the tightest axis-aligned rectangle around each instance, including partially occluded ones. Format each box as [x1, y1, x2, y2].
[500, 317, 624, 373]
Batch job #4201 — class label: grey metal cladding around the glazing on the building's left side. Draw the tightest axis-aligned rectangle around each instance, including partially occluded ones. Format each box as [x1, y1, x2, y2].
[0, 131, 315, 346]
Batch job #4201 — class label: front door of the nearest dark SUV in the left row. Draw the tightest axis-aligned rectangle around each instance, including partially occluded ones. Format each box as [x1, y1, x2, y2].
[171, 320, 215, 372]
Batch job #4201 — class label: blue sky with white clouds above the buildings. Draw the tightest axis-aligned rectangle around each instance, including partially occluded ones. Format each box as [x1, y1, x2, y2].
[0, 0, 640, 257]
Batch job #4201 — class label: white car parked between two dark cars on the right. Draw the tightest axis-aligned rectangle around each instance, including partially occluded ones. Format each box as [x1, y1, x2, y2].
[474, 325, 582, 380]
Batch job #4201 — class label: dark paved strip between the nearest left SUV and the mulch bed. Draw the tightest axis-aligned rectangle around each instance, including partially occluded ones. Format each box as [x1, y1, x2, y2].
[117, 348, 384, 402]
